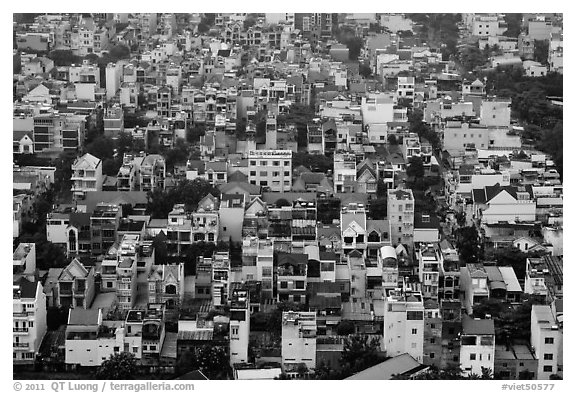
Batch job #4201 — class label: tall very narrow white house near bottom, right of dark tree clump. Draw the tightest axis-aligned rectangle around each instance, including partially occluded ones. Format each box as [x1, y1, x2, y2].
[230, 287, 250, 365]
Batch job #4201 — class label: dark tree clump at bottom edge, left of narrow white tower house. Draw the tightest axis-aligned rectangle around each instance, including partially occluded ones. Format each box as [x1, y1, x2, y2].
[176, 345, 230, 379]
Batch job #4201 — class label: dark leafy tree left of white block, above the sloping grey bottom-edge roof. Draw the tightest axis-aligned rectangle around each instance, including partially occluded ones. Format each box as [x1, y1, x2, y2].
[340, 335, 381, 373]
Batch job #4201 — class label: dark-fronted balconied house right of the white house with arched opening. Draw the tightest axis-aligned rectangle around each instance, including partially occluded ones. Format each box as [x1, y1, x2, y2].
[90, 203, 122, 255]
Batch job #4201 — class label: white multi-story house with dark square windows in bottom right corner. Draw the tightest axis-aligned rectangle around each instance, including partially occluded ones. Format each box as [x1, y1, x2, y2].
[530, 304, 563, 379]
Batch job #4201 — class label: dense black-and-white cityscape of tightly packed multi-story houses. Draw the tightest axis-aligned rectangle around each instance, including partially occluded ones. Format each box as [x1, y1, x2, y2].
[12, 13, 563, 380]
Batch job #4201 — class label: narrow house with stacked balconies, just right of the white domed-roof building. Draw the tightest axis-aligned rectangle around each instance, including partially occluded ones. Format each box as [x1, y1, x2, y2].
[415, 243, 444, 300]
